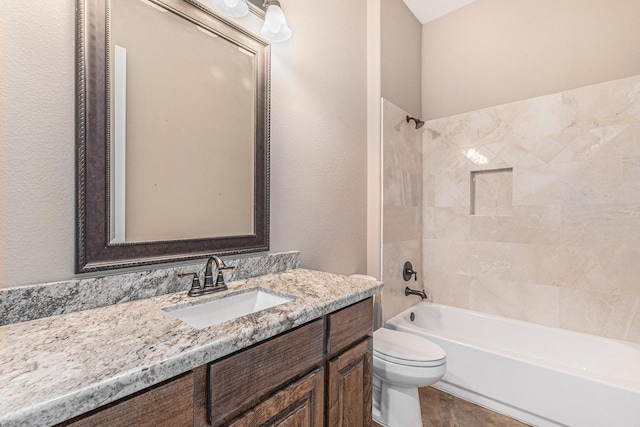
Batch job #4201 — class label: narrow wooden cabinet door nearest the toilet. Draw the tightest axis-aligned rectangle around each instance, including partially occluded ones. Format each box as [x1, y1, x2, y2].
[327, 337, 373, 427]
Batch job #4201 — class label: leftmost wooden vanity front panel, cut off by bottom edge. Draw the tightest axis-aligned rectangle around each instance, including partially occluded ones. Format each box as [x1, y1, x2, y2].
[58, 372, 194, 427]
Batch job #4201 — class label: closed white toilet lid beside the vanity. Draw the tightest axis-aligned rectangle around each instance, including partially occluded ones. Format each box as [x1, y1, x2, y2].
[373, 328, 447, 366]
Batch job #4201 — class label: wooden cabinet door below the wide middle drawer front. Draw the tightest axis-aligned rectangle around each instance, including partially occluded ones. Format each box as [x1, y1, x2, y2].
[229, 368, 324, 427]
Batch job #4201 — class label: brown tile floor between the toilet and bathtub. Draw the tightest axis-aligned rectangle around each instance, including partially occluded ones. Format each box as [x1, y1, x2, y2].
[373, 387, 528, 427]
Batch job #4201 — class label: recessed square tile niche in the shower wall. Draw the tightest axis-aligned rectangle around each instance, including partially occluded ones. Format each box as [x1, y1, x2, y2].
[471, 168, 513, 216]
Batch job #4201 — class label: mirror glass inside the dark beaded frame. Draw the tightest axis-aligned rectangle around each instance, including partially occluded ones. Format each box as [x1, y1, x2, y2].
[109, 0, 256, 243]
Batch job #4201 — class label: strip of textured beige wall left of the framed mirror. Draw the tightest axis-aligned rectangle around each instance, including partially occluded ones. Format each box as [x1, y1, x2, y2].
[0, 0, 75, 287]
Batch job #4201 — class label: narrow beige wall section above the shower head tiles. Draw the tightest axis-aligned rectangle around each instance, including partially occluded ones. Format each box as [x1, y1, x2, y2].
[380, 0, 422, 117]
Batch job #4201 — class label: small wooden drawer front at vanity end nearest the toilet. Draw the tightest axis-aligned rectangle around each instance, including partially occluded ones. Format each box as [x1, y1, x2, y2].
[327, 298, 373, 358]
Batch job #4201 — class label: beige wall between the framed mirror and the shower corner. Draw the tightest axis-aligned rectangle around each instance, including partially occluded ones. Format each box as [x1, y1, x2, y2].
[271, 0, 367, 274]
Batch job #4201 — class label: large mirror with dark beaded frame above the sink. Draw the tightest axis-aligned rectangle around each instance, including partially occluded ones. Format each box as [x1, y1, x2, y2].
[76, 0, 270, 273]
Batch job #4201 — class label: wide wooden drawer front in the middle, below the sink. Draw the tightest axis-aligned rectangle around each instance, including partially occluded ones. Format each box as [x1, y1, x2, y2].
[208, 319, 324, 427]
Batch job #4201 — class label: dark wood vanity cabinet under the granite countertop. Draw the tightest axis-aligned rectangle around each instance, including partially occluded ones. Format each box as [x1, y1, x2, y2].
[61, 298, 373, 427]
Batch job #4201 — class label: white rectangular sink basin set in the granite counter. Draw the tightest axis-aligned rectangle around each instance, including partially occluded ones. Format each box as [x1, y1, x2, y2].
[164, 289, 293, 329]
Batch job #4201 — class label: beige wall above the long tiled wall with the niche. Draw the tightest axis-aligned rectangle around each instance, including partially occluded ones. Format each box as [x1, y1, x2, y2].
[422, 0, 640, 119]
